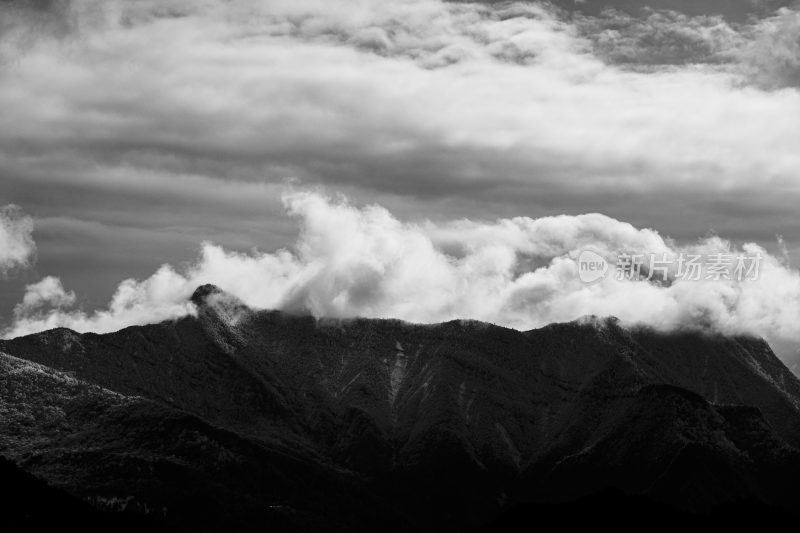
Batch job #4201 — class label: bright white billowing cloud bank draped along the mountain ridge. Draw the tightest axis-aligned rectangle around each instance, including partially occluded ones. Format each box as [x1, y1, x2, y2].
[5, 190, 800, 368]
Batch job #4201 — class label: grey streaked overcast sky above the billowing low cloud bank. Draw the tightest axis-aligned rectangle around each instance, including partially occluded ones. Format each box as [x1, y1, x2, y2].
[0, 0, 800, 366]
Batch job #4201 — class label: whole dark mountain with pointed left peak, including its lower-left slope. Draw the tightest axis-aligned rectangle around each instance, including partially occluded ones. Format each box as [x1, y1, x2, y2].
[0, 286, 800, 531]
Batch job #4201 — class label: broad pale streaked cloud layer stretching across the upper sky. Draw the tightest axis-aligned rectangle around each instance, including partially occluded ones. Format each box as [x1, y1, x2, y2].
[0, 0, 800, 238]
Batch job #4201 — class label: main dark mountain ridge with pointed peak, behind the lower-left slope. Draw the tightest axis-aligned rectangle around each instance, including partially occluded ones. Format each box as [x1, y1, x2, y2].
[0, 286, 800, 530]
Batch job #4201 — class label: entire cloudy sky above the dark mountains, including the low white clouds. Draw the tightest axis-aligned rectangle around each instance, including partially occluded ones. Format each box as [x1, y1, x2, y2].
[0, 0, 800, 366]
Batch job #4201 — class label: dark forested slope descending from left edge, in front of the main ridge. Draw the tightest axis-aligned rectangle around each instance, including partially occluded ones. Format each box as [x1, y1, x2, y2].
[0, 354, 412, 531]
